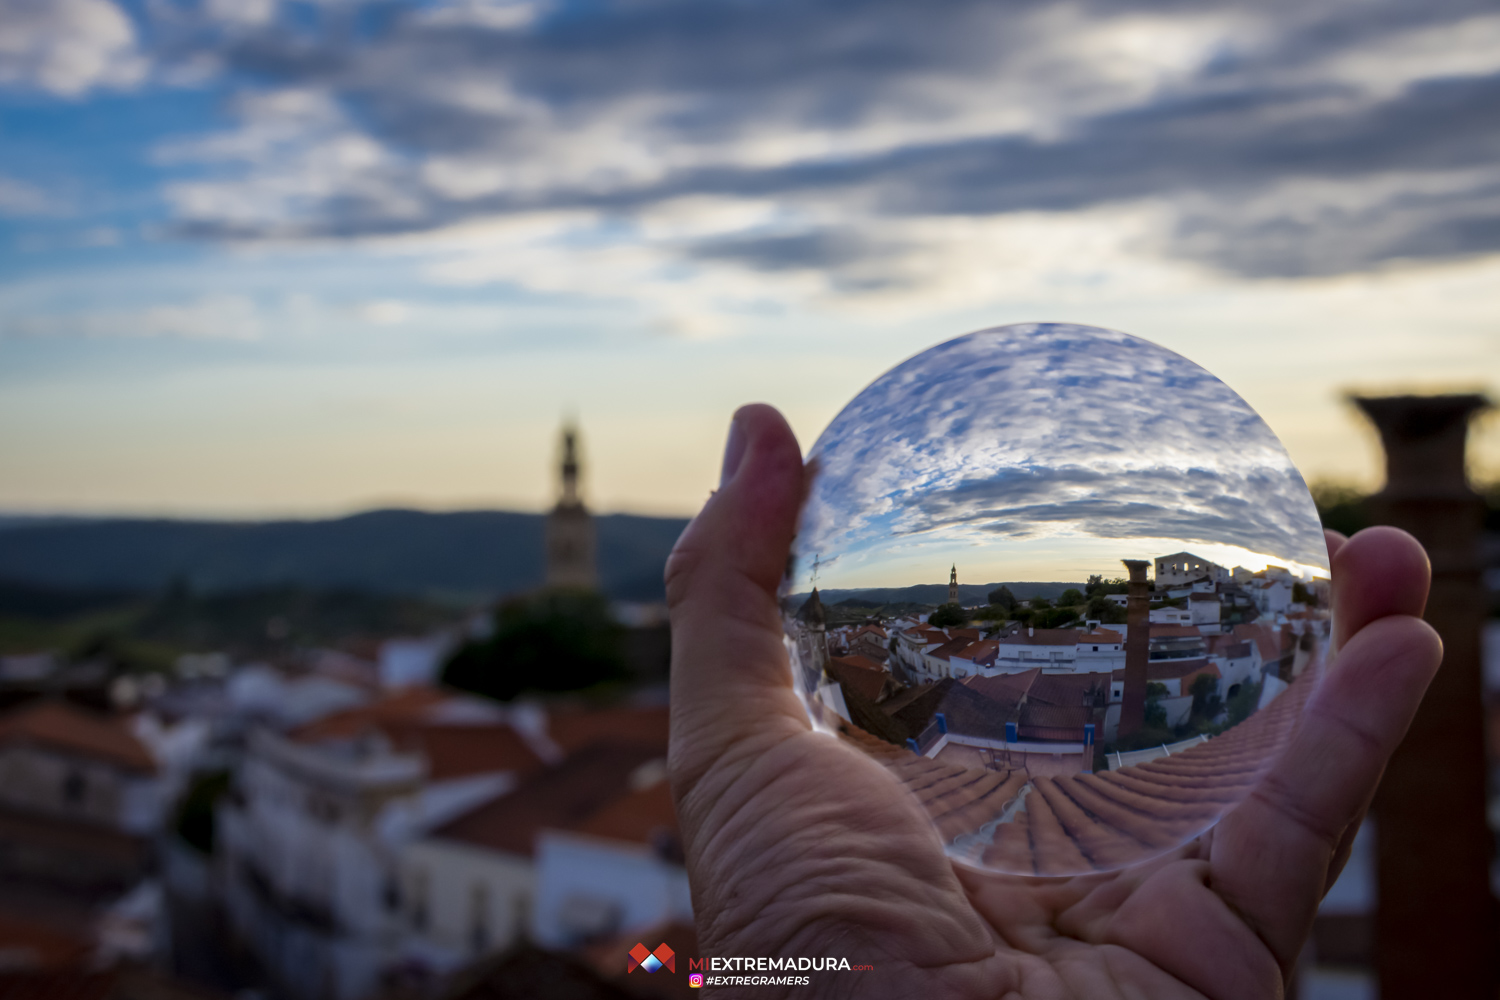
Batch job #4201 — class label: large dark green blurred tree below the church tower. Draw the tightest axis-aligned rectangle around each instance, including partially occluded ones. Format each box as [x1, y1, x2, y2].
[443, 589, 627, 702]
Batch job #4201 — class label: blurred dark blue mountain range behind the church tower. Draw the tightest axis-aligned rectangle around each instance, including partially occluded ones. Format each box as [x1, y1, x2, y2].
[0, 510, 687, 601]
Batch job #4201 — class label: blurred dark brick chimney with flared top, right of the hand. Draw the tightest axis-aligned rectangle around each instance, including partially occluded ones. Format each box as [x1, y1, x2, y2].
[1353, 394, 1497, 1000]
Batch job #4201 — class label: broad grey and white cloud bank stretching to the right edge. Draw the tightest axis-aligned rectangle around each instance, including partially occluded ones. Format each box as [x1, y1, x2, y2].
[20, 0, 1500, 314]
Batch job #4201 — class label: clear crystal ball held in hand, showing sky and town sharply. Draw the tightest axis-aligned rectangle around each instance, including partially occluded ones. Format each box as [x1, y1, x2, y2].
[782, 324, 1331, 876]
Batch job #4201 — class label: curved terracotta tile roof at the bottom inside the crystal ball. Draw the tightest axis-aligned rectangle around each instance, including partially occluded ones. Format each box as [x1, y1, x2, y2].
[845, 659, 1316, 876]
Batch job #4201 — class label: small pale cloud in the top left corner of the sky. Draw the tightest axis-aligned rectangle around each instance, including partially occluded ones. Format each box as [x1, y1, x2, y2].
[0, 0, 147, 97]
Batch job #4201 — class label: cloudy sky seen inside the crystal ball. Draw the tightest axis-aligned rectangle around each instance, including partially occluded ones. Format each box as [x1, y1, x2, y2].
[791, 324, 1328, 592]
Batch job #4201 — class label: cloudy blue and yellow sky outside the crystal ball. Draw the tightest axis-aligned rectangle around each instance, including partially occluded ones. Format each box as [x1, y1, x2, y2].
[0, 0, 1500, 517]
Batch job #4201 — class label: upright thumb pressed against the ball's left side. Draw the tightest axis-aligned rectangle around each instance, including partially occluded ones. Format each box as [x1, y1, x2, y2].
[666, 403, 807, 778]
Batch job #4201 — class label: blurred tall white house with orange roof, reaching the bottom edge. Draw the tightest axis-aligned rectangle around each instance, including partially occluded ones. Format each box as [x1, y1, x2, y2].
[216, 687, 545, 1000]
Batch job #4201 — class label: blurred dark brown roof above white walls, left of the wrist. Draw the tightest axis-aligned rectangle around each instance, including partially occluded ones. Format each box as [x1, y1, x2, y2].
[432, 742, 663, 858]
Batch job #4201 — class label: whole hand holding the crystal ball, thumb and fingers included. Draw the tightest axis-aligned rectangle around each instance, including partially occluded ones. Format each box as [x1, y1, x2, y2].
[666, 406, 1442, 1000]
